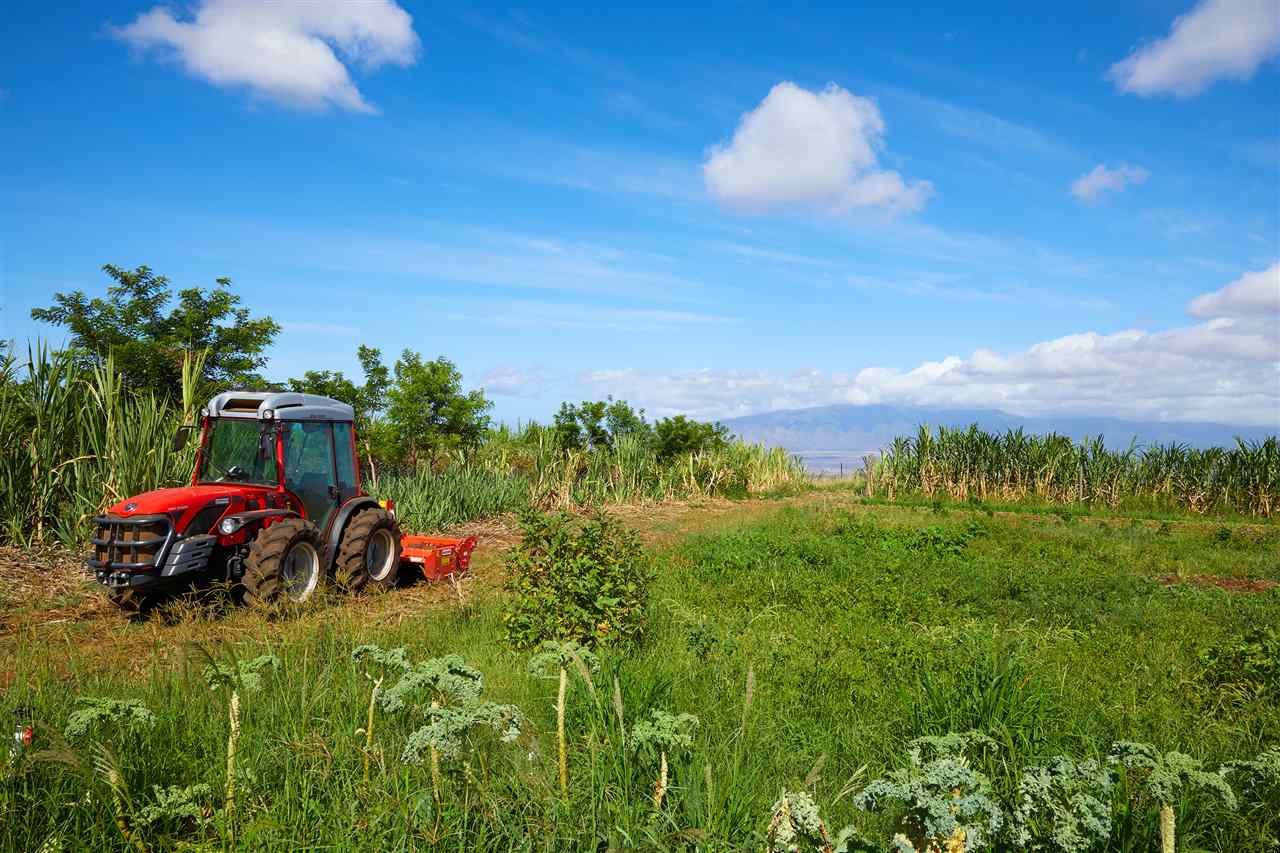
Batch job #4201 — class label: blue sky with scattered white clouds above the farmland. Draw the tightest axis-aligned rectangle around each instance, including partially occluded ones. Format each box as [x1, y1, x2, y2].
[0, 0, 1280, 425]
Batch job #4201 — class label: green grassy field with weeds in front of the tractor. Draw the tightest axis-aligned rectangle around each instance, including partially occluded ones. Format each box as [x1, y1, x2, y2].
[0, 491, 1280, 850]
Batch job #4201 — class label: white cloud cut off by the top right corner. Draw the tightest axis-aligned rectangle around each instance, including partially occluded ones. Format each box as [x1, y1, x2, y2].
[1107, 0, 1280, 97]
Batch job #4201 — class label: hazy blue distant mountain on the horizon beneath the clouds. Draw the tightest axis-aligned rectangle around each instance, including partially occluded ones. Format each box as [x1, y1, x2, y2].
[723, 405, 1280, 459]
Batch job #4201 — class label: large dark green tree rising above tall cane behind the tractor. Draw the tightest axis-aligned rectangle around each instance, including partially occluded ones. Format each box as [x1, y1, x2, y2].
[31, 264, 280, 398]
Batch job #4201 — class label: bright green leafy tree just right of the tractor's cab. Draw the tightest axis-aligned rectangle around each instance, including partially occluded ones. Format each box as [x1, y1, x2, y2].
[387, 350, 493, 467]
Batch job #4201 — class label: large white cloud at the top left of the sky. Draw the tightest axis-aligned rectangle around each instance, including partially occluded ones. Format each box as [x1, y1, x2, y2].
[111, 0, 419, 113]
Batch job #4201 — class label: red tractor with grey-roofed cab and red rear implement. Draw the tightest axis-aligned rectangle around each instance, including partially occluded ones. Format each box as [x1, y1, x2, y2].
[88, 391, 475, 612]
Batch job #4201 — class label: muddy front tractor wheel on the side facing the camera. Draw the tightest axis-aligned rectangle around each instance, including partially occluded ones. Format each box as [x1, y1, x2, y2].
[243, 519, 325, 608]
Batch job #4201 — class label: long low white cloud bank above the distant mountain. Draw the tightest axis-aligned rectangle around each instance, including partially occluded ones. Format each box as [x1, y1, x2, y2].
[584, 264, 1280, 427]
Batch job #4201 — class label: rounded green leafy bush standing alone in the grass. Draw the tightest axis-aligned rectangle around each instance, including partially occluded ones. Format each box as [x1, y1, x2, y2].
[503, 511, 652, 648]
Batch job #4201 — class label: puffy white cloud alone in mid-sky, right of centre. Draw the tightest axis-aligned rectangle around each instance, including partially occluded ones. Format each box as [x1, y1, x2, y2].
[703, 82, 933, 213]
